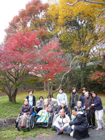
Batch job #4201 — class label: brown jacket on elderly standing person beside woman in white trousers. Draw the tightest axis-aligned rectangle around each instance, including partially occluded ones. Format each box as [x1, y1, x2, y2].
[85, 96, 95, 113]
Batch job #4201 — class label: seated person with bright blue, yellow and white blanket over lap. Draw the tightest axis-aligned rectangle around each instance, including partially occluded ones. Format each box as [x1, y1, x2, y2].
[37, 100, 52, 123]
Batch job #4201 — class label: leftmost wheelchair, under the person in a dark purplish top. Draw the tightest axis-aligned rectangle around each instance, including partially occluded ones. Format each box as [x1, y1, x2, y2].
[16, 114, 35, 131]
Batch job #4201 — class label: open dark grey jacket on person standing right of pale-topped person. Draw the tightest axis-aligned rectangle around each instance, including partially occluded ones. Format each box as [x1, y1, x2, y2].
[69, 92, 79, 108]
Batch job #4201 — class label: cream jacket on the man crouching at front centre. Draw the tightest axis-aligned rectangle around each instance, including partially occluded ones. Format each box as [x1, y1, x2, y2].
[53, 115, 70, 128]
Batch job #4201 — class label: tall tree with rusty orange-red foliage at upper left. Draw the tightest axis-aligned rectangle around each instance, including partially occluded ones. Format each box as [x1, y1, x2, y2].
[5, 0, 49, 41]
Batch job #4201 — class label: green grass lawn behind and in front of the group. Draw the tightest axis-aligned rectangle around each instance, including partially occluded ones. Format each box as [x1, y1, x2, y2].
[0, 91, 105, 140]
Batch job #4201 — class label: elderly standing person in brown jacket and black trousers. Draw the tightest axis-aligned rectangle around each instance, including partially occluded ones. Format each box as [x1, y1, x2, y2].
[85, 92, 95, 129]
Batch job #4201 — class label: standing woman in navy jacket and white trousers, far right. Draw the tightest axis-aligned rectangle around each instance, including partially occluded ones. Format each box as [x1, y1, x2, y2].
[91, 91, 105, 130]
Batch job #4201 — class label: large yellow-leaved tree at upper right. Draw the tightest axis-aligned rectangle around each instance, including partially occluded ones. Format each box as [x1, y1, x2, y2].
[48, 0, 105, 87]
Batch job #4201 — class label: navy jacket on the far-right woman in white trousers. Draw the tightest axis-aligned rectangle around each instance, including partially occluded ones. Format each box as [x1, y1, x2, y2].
[93, 96, 103, 110]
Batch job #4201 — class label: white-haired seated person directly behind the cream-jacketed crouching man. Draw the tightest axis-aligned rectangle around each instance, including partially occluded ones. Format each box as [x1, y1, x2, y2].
[53, 101, 71, 123]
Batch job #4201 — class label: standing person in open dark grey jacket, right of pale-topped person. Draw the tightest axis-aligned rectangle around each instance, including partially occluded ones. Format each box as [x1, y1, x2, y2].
[69, 87, 79, 109]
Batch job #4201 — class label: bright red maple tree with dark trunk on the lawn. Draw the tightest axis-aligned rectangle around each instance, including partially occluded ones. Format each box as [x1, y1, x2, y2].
[0, 32, 69, 102]
